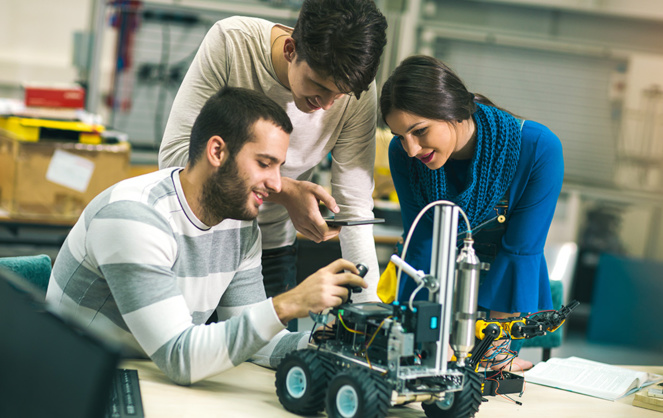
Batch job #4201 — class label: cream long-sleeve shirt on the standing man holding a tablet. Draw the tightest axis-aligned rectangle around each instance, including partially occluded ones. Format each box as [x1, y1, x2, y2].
[159, 17, 379, 302]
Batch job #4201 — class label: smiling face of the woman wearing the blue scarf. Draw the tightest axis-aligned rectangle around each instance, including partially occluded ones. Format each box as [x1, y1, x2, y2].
[385, 109, 474, 170]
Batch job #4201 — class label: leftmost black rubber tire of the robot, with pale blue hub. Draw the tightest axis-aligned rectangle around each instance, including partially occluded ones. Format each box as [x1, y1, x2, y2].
[275, 349, 333, 415]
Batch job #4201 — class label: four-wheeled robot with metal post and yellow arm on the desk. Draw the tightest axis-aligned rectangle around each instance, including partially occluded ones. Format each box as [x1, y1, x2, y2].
[276, 205, 578, 418]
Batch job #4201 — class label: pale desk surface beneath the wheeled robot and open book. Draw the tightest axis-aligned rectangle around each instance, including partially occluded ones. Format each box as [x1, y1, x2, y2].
[121, 360, 663, 418]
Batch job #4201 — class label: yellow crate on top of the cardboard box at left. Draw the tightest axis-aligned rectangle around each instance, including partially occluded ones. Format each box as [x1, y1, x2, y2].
[0, 116, 105, 145]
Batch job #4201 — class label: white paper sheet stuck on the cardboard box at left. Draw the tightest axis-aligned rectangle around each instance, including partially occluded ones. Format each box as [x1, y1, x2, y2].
[46, 149, 94, 193]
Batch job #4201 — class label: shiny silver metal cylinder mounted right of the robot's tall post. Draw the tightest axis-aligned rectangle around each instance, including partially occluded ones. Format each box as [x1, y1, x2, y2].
[451, 239, 481, 366]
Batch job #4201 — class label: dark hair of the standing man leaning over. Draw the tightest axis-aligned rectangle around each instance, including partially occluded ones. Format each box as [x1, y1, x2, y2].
[292, 0, 387, 98]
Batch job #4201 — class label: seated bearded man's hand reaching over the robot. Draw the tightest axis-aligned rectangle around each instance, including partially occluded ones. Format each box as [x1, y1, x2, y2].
[272, 258, 368, 324]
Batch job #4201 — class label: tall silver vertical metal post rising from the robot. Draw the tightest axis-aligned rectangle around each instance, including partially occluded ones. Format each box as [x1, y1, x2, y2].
[429, 205, 458, 373]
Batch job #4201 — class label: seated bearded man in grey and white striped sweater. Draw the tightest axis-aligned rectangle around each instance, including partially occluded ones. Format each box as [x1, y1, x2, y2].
[46, 88, 366, 384]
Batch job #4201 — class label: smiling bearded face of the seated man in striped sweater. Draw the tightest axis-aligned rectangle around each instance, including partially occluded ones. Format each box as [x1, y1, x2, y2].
[201, 119, 289, 225]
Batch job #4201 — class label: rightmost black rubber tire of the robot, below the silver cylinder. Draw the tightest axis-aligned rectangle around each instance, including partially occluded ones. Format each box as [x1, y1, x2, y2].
[421, 367, 482, 418]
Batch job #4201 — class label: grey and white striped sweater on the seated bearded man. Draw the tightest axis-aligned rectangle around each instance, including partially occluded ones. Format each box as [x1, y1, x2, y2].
[46, 168, 307, 384]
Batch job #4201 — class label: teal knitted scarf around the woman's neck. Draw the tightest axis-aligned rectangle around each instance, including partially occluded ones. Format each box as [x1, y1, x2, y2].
[410, 103, 521, 232]
